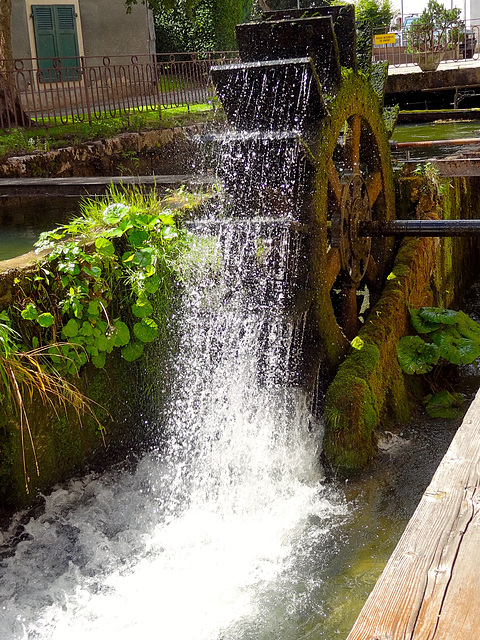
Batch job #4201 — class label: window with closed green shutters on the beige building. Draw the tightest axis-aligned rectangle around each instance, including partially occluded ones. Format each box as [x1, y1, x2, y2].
[32, 4, 80, 82]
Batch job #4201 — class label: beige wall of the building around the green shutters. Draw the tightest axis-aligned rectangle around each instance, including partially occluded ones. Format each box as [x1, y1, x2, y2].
[12, 0, 155, 58]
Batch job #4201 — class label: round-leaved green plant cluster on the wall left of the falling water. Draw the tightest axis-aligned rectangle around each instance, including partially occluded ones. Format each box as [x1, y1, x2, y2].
[20, 189, 186, 375]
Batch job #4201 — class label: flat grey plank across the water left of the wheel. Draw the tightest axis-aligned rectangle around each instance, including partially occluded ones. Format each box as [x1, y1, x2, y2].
[0, 175, 208, 197]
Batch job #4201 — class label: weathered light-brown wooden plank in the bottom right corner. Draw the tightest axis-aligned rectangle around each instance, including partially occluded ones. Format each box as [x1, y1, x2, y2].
[347, 384, 480, 640]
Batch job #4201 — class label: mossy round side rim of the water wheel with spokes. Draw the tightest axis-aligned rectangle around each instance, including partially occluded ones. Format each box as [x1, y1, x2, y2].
[313, 74, 395, 364]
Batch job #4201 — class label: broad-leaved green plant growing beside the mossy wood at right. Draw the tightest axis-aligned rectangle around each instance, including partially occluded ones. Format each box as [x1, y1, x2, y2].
[397, 307, 480, 417]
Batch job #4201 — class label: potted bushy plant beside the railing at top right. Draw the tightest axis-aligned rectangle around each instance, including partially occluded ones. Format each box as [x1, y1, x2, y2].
[407, 0, 463, 71]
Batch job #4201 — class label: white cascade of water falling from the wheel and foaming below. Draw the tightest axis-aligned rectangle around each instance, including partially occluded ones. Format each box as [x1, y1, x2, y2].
[0, 60, 346, 640]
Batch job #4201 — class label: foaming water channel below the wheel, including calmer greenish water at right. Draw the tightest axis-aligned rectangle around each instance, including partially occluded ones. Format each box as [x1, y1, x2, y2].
[0, 117, 479, 640]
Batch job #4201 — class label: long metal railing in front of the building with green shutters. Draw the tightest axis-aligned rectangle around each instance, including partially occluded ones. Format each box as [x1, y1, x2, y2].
[0, 51, 237, 131]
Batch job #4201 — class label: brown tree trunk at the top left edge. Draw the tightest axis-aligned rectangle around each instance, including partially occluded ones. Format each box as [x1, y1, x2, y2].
[0, 0, 31, 129]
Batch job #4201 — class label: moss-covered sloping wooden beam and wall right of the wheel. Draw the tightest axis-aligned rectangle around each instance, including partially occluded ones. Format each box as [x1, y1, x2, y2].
[324, 178, 480, 474]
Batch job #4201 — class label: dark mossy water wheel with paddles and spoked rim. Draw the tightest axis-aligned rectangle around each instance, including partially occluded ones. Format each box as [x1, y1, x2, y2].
[212, 5, 395, 365]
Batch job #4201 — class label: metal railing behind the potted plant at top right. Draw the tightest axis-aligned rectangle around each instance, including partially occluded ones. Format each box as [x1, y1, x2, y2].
[373, 25, 480, 67]
